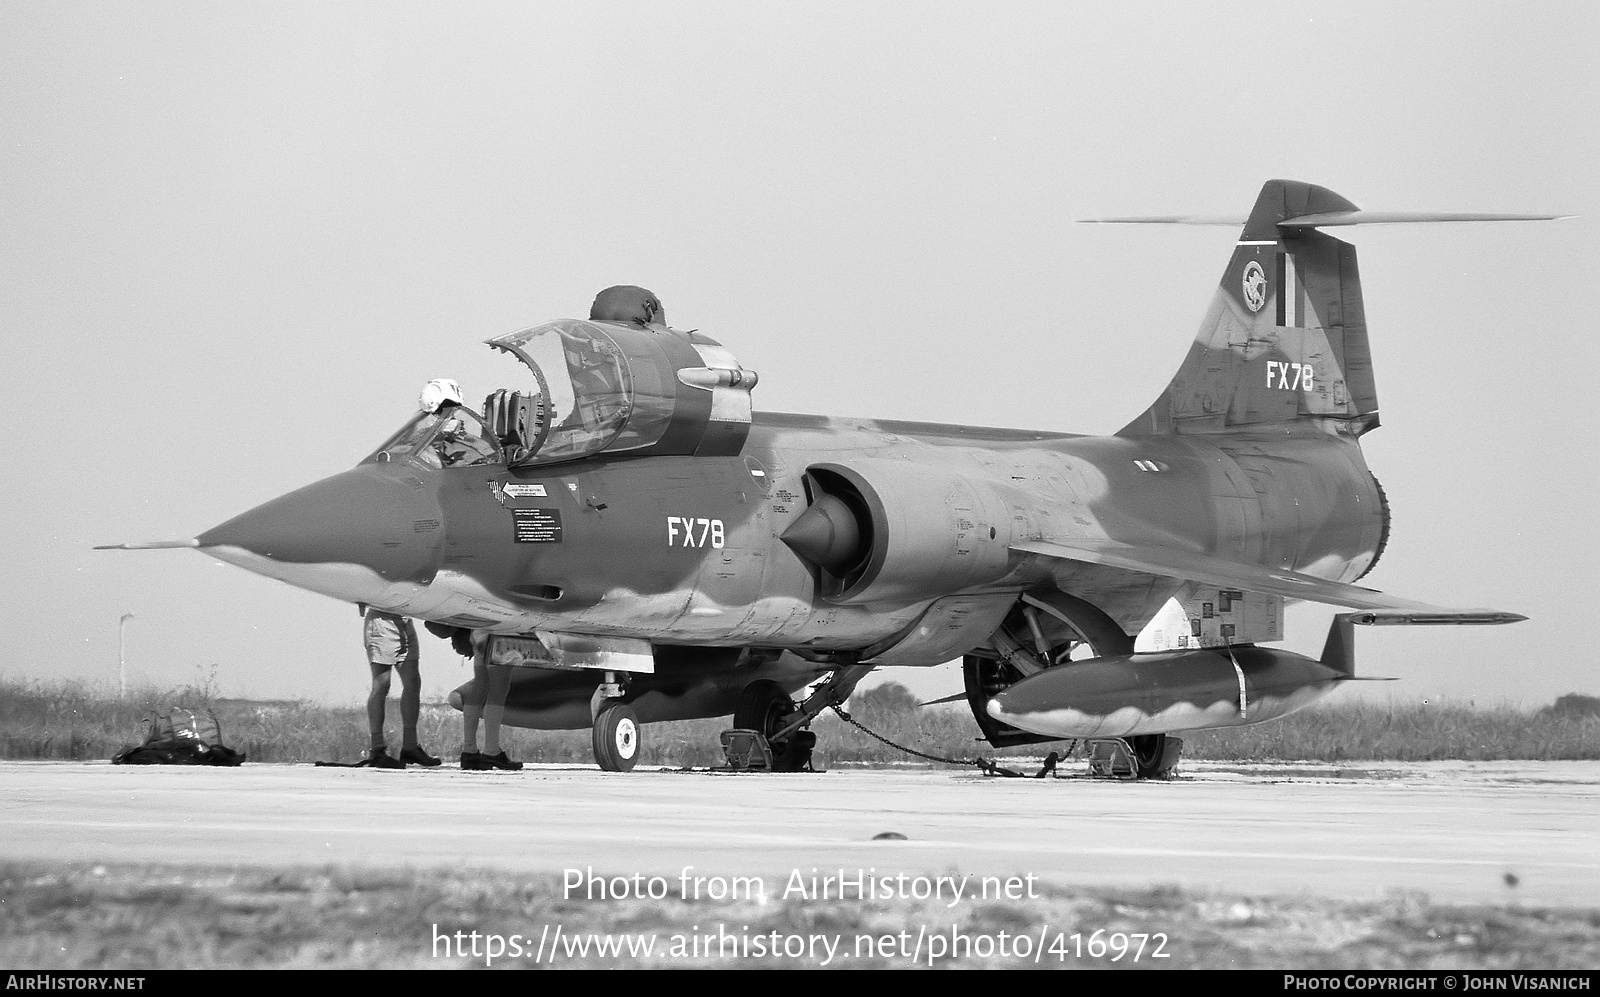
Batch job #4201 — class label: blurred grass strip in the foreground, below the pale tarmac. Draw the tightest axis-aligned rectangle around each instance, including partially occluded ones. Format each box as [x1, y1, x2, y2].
[0, 864, 1600, 970]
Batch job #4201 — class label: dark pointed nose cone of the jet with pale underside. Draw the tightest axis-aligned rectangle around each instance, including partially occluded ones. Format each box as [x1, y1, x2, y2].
[197, 466, 445, 600]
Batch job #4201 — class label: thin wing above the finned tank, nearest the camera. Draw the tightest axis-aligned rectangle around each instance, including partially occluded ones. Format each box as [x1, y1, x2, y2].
[1011, 539, 1526, 626]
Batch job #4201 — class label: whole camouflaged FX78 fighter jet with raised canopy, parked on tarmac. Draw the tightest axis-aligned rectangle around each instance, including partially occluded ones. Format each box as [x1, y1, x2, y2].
[100, 181, 1547, 776]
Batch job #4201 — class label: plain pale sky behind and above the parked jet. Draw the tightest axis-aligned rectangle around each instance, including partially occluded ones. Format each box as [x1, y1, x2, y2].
[0, 0, 1600, 706]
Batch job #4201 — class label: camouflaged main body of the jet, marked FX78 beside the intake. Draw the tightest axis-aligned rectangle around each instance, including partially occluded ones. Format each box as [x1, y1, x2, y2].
[200, 414, 1382, 664]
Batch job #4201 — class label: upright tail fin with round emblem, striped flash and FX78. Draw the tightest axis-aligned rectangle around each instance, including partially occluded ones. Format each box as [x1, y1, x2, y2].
[1118, 179, 1378, 435]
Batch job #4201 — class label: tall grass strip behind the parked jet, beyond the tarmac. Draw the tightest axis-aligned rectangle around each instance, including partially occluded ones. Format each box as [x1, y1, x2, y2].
[0, 679, 1600, 767]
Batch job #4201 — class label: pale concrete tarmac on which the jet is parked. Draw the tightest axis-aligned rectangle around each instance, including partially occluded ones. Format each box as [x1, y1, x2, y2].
[0, 762, 1600, 907]
